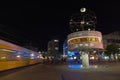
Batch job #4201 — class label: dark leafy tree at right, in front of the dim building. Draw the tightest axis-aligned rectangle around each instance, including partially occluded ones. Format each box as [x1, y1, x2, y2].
[105, 44, 120, 59]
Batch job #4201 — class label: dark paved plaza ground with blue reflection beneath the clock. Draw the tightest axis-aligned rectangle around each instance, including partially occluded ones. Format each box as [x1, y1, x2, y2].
[0, 63, 120, 80]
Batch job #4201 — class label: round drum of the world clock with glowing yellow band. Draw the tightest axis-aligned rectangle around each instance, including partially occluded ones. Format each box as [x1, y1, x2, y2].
[67, 31, 103, 51]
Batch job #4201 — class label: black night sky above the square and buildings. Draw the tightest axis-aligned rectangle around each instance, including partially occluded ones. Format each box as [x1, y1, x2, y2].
[0, 0, 120, 50]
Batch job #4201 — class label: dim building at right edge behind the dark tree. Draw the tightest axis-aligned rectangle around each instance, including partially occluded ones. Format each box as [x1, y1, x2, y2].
[103, 31, 120, 49]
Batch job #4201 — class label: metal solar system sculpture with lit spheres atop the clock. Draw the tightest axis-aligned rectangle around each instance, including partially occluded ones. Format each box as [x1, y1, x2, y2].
[69, 8, 97, 32]
